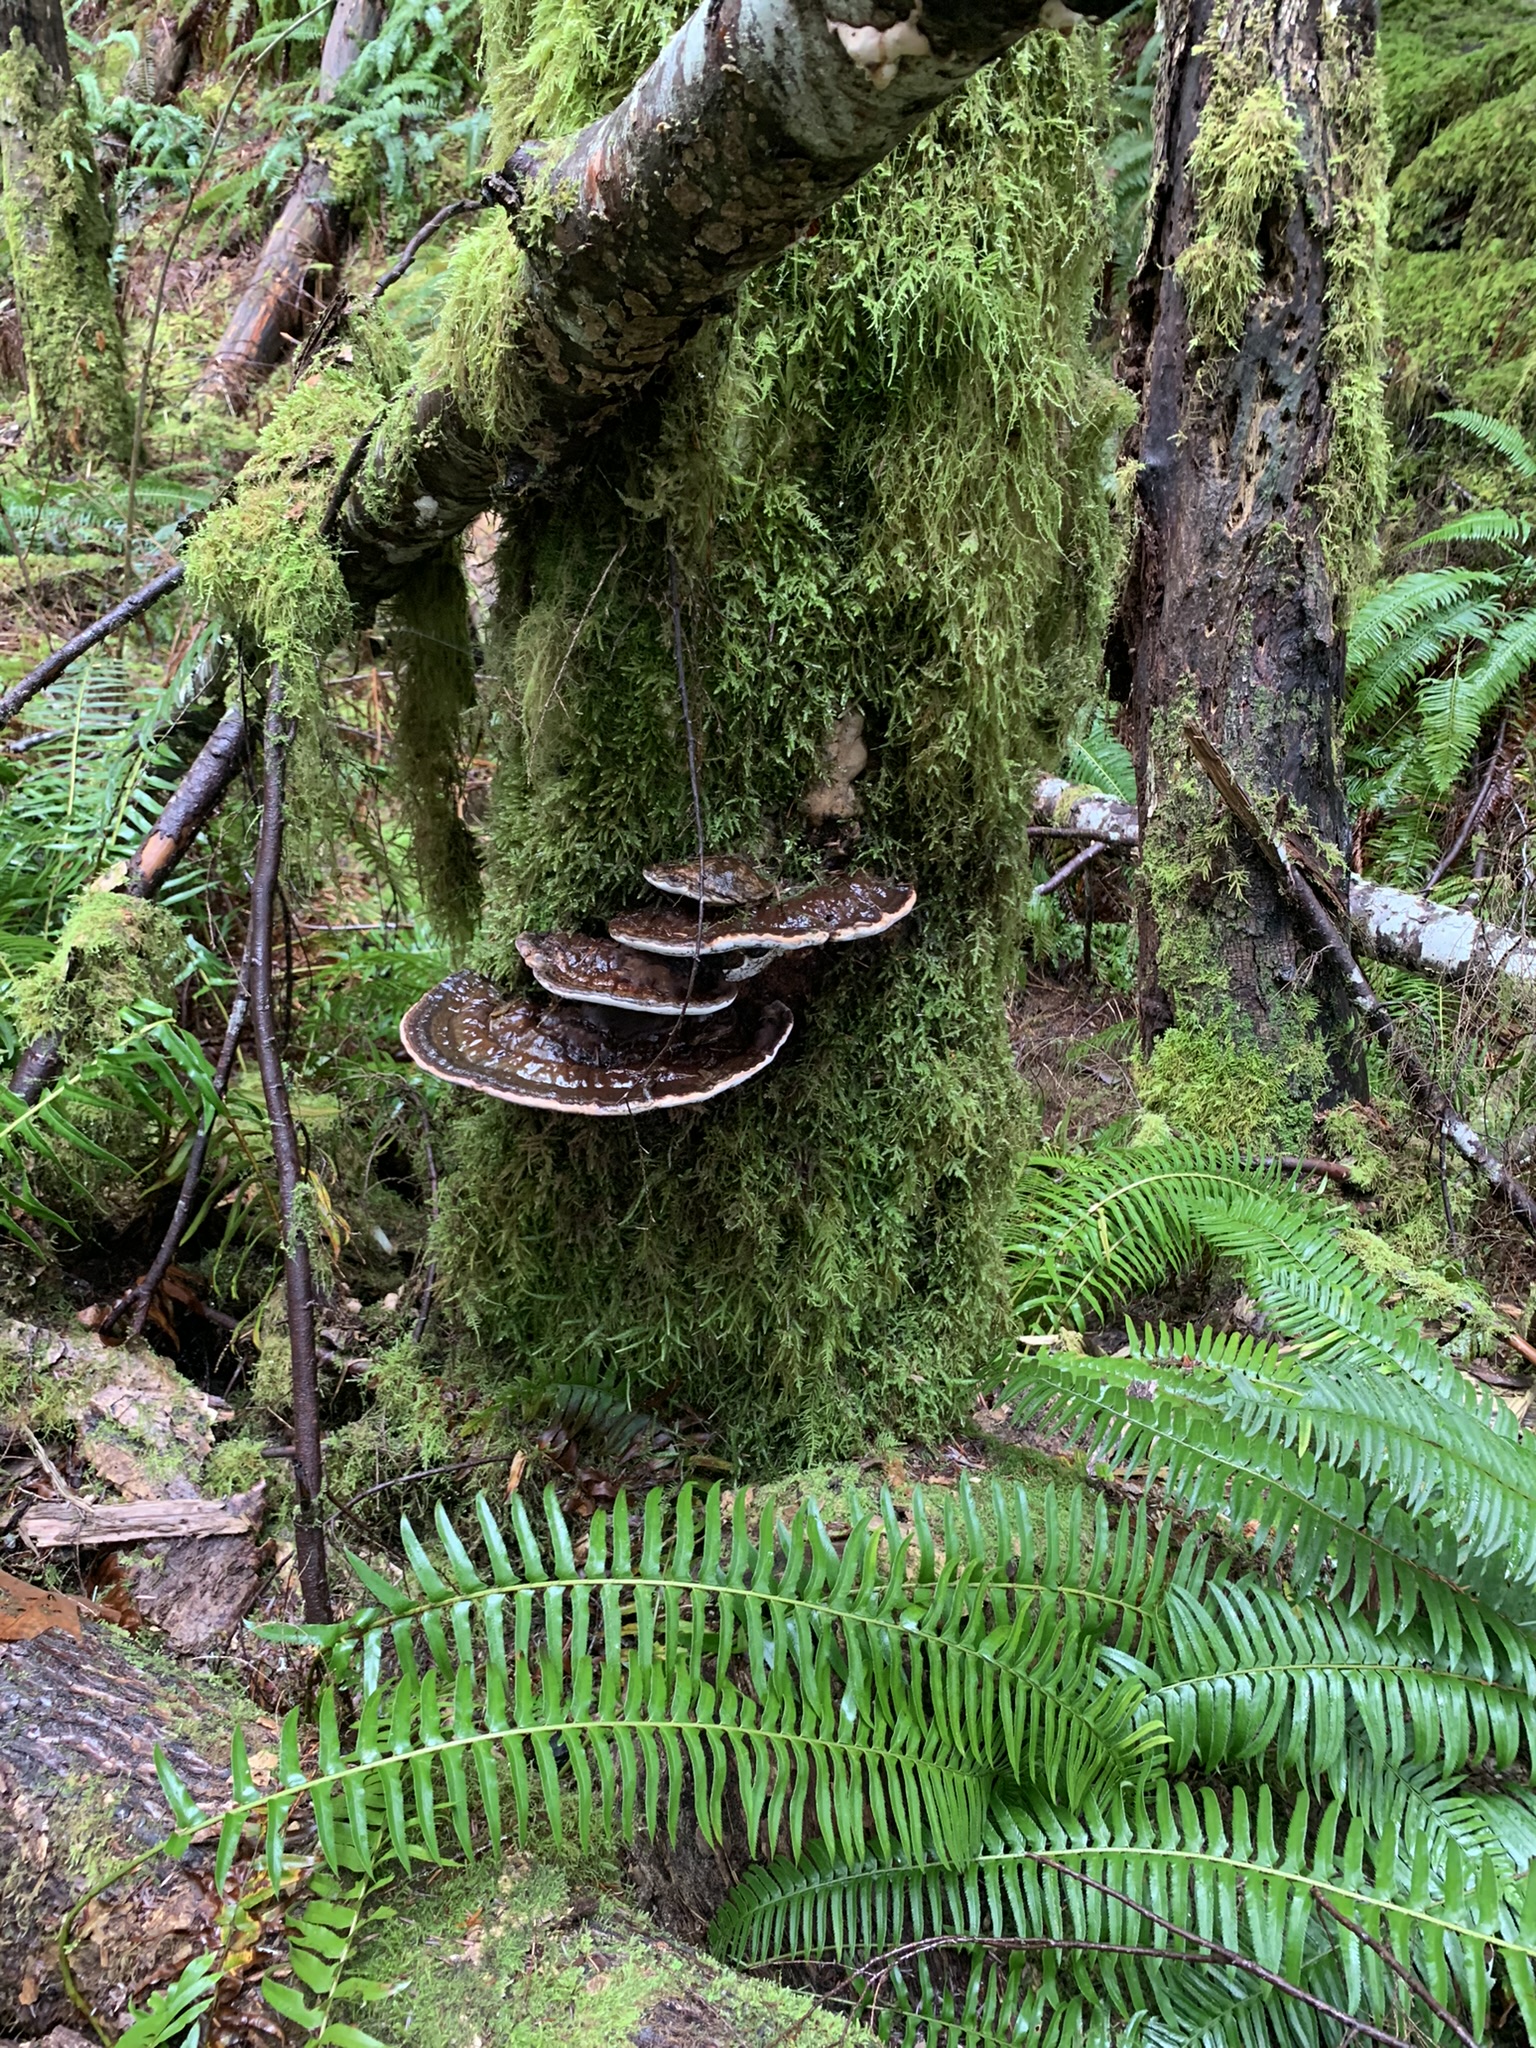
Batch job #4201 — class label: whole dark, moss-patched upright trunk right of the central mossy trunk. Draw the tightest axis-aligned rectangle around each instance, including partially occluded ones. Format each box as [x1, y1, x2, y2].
[1110, 0, 1386, 1114]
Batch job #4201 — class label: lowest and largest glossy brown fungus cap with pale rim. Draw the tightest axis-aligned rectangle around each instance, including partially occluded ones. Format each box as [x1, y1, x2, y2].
[399, 973, 793, 1116]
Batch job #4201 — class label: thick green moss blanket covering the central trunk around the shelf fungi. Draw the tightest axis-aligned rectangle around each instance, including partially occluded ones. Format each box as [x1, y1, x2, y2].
[438, 6, 1124, 1458]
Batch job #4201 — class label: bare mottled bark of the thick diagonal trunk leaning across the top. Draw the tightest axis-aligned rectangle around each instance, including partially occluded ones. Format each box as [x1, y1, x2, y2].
[338, 0, 1104, 602]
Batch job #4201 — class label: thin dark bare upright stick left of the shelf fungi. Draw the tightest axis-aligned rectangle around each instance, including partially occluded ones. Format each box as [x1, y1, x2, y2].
[248, 662, 332, 1622]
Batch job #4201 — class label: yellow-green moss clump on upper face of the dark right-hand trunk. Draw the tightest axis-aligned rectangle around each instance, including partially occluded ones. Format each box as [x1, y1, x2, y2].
[1174, 56, 1303, 348]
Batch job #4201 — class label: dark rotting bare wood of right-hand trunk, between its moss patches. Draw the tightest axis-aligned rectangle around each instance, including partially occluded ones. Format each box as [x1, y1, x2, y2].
[1106, 0, 1376, 1085]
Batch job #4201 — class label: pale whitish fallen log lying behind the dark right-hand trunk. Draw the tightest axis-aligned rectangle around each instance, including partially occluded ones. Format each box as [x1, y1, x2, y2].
[1034, 776, 1536, 983]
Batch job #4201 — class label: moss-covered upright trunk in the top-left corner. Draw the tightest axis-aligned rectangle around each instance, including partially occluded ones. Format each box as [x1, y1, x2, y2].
[0, 0, 133, 465]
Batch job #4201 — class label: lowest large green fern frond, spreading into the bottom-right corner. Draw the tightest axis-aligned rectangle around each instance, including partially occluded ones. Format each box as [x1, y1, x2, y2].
[711, 1786, 1536, 2040]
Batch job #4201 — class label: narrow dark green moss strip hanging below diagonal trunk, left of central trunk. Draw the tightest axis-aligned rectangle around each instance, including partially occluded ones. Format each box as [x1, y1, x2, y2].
[391, 551, 479, 942]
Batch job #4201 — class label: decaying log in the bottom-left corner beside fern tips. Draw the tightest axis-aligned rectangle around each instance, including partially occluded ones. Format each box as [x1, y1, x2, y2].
[0, 1620, 260, 2038]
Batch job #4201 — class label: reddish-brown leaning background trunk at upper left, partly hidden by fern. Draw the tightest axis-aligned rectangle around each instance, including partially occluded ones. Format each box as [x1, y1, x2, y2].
[195, 0, 383, 412]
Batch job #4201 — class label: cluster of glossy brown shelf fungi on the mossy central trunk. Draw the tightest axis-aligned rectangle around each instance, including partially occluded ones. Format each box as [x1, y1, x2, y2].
[399, 854, 918, 1116]
